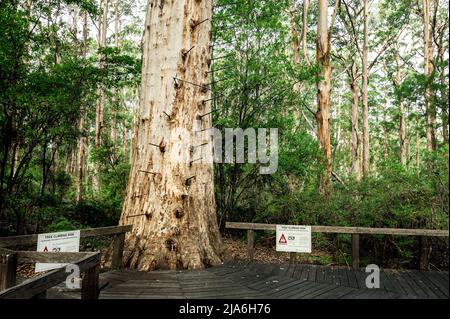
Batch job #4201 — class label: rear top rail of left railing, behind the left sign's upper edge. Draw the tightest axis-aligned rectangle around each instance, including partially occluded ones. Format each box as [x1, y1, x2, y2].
[0, 225, 132, 247]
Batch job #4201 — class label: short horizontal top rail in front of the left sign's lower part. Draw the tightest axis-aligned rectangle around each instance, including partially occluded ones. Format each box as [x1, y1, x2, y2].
[17, 251, 92, 263]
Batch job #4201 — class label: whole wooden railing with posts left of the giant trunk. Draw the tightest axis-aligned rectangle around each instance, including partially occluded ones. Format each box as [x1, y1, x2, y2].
[0, 226, 131, 299]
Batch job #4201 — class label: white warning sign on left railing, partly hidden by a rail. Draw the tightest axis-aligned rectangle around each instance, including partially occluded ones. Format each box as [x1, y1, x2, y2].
[35, 230, 80, 272]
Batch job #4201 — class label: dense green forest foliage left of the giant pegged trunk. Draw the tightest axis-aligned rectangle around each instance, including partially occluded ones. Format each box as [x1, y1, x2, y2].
[0, 0, 140, 234]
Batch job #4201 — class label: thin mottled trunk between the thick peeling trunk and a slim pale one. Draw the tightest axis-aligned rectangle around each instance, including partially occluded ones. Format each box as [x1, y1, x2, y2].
[350, 62, 361, 181]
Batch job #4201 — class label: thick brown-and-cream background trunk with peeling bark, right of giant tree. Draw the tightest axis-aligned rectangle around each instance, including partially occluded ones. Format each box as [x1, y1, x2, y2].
[316, 0, 332, 195]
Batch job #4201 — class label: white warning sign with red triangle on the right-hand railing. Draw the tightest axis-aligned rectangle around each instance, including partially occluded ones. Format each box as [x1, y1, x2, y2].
[276, 225, 311, 253]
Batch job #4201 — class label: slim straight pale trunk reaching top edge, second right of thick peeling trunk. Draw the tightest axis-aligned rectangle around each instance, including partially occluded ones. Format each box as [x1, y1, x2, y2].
[361, 0, 370, 177]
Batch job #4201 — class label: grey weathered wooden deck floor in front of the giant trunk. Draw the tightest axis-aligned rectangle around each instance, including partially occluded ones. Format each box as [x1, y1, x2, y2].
[47, 262, 449, 299]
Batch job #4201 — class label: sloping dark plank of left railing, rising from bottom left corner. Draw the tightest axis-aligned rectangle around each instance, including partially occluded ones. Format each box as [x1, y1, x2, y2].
[0, 252, 101, 299]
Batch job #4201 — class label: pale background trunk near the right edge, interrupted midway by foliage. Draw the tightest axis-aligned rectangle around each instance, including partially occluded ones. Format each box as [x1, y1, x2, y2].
[422, 0, 436, 151]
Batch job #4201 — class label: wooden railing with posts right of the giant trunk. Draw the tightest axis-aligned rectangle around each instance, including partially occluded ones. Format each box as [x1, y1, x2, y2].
[226, 222, 449, 270]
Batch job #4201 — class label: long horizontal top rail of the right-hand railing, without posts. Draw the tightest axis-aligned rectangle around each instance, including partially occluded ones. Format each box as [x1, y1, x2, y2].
[226, 222, 449, 237]
